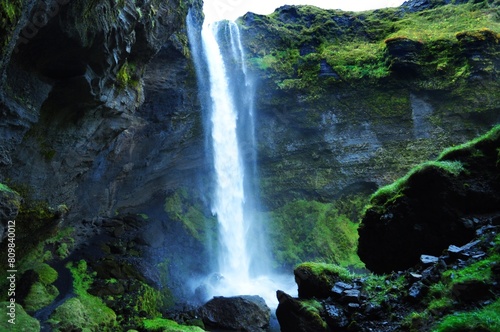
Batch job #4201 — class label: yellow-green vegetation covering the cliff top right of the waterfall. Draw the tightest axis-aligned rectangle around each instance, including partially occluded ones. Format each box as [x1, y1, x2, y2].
[240, 1, 500, 98]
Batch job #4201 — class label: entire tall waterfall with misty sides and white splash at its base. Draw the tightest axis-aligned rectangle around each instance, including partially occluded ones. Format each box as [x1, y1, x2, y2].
[188, 10, 293, 307]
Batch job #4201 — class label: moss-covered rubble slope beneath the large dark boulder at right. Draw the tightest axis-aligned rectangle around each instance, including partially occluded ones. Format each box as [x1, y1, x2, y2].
[276, 222, 500, 332]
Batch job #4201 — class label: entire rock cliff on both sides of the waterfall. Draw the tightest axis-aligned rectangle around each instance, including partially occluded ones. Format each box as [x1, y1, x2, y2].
[0, 0, 500, 330]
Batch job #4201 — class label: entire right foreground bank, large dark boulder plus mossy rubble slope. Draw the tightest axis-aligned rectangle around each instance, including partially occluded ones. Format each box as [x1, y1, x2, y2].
[276, 126, 500, 332]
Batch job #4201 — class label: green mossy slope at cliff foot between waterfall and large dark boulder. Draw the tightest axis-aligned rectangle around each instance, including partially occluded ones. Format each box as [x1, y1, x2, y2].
[268, 200, 364, 266]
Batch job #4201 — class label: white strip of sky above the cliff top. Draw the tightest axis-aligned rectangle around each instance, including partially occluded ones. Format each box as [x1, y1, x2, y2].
[204, 0, 404, 22]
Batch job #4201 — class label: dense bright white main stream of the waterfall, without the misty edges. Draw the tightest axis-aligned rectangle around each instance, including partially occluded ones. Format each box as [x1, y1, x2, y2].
[202, 22, 250, 284]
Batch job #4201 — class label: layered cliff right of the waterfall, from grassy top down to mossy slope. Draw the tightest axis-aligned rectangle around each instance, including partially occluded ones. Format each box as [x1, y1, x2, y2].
[240, 1, 500, 207]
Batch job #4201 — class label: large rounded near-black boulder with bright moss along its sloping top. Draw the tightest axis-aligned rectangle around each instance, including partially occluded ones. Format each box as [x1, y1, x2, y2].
[358, 126, 500, 273]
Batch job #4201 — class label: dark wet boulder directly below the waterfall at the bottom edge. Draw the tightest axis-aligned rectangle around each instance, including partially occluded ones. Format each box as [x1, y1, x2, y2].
[199, 295, 271, 332]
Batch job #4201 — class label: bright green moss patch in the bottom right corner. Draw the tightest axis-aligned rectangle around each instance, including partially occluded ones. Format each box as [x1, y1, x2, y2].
[433, 299, 500, 332]
